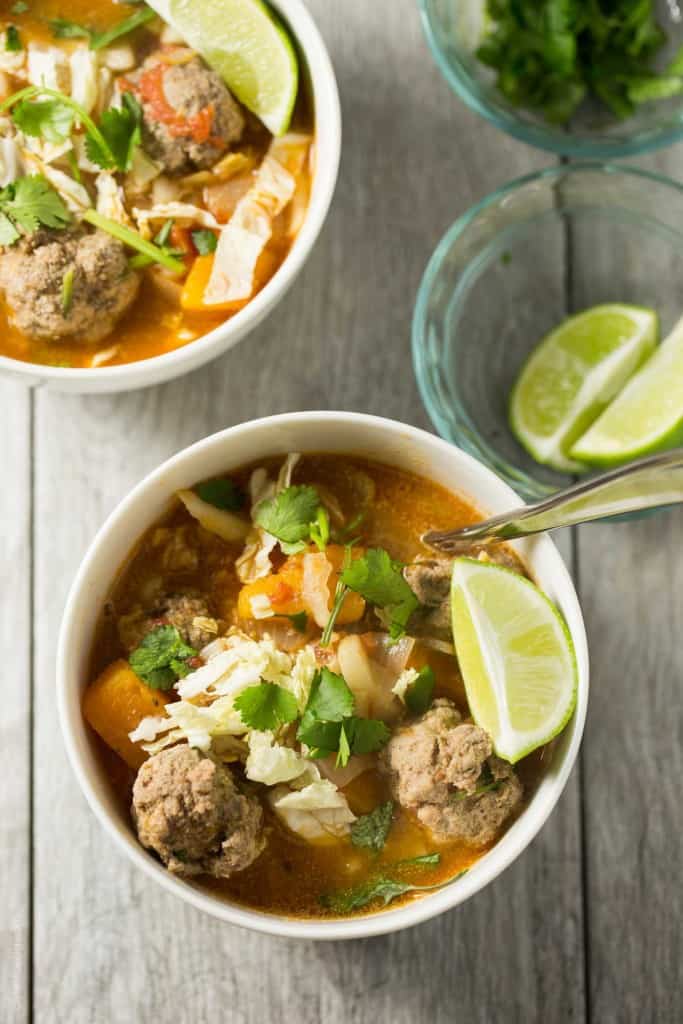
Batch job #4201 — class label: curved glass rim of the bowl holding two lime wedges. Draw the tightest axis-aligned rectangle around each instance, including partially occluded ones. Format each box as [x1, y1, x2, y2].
[411, 160, 683, 501]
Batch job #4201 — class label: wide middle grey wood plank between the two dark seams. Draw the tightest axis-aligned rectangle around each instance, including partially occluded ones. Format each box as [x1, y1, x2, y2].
[35, 0, 584, 1024]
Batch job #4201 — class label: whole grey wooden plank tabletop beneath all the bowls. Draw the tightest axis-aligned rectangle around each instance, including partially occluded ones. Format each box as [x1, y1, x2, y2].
[0, 0, 683, 1024]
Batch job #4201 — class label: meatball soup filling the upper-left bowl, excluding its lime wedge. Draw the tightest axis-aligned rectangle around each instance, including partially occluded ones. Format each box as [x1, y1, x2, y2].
[0, 0, 313, 369]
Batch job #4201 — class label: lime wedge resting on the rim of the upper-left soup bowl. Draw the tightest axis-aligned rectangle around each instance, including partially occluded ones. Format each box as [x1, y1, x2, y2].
[150, 0, 299, 135]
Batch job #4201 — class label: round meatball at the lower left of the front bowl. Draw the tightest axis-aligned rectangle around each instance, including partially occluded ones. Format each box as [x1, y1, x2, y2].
[132, 743, 265, 879]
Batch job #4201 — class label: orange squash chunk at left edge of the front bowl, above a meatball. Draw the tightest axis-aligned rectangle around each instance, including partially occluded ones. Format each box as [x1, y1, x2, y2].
[83, 658, 169, 768]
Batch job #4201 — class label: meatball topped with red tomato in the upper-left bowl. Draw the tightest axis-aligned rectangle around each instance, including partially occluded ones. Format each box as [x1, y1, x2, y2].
[126, 53, 245, 174]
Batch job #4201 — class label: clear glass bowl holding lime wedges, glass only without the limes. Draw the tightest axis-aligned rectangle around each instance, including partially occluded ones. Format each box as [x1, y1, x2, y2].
[413, 163, 683, 500]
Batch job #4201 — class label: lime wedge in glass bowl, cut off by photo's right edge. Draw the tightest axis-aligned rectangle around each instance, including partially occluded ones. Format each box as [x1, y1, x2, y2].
[571, 319, 683, 466]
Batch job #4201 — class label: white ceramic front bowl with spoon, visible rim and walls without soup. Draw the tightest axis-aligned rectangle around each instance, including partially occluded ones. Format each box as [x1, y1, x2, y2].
[57, 413, 588, 939]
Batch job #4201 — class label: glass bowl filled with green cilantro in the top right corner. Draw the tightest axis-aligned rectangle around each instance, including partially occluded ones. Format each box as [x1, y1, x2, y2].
[420, 0, 683, 158]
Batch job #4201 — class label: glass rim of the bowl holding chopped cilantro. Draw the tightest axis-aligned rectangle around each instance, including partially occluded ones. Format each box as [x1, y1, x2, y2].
[418, 0, 683, 160]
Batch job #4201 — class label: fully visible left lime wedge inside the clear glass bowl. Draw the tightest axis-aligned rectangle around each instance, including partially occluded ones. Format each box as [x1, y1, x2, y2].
[510, 304, 657, 473]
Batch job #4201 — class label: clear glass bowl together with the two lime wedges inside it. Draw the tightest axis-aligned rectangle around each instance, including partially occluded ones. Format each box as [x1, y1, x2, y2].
[413, 163, 683, 501]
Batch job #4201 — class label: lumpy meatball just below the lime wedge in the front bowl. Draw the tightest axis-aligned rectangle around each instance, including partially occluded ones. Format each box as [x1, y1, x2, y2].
[382, 699, 522, 846]
